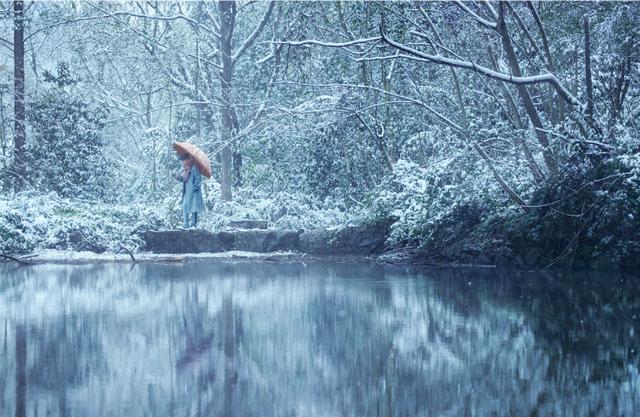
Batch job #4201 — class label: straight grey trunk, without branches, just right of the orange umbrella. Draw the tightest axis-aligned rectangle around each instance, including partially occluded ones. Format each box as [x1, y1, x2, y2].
[218, 0, 236, 201]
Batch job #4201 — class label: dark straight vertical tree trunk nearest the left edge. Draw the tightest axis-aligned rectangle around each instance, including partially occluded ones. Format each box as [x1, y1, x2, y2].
[13, 0, 27, 191]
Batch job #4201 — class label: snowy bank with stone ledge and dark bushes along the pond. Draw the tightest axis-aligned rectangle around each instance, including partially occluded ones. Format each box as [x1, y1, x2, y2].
[0, 182, 640, 270]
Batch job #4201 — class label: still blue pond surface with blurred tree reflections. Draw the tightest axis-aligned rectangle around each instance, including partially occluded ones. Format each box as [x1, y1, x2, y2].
[0, 261, 640, 417]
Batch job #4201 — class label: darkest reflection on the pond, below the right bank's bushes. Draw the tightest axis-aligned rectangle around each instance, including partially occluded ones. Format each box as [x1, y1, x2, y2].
[439, 272, 640, 380]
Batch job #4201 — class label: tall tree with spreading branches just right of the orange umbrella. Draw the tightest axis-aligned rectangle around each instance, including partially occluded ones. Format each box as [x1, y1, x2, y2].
[130, 0, 275, 201]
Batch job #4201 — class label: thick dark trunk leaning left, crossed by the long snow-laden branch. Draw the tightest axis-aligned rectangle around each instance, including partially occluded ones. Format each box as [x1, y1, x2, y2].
[497, 2, 558, 177]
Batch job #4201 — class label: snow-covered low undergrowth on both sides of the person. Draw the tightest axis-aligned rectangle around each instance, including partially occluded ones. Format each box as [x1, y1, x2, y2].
[0, 192, 356, 257]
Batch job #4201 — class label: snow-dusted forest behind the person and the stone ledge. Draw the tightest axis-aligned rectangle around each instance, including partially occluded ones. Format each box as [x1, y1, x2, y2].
[0, 0, 640, 268]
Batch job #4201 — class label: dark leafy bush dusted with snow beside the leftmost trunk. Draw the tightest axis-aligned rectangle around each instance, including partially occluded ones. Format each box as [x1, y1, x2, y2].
[24, 64, 110, 198]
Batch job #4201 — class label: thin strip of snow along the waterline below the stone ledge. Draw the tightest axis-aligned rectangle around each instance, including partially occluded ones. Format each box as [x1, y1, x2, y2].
[17, 249, 302, 263]
